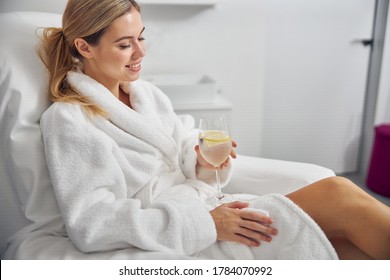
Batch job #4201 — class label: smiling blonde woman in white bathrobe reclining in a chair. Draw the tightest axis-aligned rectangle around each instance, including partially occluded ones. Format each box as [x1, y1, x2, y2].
[37, 0, 390, 259]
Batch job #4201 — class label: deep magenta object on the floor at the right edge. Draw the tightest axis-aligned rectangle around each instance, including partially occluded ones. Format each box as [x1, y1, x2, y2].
[367, 124, 390, 197]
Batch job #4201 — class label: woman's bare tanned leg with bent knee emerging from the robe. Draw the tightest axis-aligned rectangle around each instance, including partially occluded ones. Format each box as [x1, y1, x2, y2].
[287, 177, 390, 259]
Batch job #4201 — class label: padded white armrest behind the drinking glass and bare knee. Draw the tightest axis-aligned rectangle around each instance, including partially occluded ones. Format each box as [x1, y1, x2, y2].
[223, 155, 335, 195]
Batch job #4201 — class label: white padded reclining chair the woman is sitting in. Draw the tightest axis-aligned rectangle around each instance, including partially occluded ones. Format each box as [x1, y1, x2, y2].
[0, 12, 334, 259]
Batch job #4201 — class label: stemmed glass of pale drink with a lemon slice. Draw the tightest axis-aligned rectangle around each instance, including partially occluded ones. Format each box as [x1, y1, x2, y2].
[199, 116, 232, 199]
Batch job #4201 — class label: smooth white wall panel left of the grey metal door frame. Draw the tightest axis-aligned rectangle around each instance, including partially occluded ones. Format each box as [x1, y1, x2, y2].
[261, 0, 375, 173]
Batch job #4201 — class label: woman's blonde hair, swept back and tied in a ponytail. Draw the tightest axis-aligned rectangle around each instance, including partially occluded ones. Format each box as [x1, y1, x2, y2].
[38, 0, 140, 116]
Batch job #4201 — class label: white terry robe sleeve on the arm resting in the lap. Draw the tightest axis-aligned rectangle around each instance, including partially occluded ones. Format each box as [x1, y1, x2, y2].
[41, 103, 216, 255]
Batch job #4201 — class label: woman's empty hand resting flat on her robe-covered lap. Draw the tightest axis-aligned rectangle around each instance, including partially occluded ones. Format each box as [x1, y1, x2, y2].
[210, 201, 277, 247]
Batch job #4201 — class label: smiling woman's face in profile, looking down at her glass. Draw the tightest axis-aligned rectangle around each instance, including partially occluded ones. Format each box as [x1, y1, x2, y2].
[83, 9, 145, 90]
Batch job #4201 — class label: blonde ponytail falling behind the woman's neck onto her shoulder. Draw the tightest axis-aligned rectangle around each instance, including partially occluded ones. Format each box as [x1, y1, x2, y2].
[38, 27, 107, 117]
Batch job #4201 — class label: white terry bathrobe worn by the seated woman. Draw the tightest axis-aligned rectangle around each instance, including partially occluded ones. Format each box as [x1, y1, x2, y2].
[4, 72, 337, 259]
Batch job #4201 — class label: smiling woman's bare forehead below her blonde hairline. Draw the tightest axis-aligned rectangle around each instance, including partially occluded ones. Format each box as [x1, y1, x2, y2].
[103, 8, 144, 40]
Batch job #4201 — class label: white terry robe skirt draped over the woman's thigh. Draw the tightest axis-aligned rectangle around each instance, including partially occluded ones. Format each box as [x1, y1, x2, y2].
[196, 194, 338, 260]
